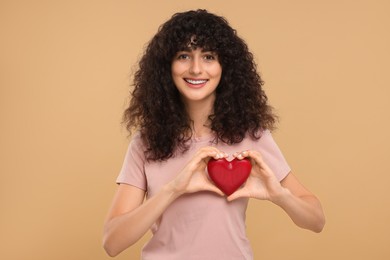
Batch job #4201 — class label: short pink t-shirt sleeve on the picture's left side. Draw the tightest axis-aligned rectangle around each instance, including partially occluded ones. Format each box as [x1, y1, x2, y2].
[116, 134, 147, 190]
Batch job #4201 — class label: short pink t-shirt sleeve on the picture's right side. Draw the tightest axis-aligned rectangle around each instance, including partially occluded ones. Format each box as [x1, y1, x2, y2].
[256, 130, 291, 181]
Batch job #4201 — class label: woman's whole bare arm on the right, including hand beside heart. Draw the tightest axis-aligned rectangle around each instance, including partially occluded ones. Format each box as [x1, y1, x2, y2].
[228, 151, 325, 232]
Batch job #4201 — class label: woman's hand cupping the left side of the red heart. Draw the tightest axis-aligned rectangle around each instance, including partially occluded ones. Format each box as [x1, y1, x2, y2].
[168, 146, 227, 196]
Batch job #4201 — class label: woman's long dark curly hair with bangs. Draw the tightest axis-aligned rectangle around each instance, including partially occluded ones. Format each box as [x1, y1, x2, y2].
[123, 10, 276, 160]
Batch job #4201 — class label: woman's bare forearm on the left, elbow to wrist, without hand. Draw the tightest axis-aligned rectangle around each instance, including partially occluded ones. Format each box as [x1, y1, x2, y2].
[103, 186, 180, 256]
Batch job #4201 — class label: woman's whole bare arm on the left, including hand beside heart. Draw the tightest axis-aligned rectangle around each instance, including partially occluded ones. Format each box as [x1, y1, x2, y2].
[103, 147, 225, 256]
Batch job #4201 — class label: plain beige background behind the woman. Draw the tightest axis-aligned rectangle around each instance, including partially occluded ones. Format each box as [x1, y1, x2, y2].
[0, 0, 390, 260]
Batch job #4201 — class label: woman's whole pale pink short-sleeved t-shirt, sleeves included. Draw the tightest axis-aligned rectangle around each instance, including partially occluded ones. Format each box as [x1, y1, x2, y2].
[117, 131, 290, 260]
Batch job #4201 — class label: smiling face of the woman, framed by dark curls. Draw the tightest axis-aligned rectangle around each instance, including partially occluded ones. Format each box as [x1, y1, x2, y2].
[171, 48, 222, 103]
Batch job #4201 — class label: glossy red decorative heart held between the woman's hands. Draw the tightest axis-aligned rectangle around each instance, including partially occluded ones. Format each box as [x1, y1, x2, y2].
[207, 158, 252, 196]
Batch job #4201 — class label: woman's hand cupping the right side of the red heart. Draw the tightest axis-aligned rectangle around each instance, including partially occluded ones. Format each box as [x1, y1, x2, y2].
[227, 150, 284, 201]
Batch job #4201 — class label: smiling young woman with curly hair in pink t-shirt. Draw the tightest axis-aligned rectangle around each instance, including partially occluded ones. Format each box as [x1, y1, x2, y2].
[103, 10, 325, 260]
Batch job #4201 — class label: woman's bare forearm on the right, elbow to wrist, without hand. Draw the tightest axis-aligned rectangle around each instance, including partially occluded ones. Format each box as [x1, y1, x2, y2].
[271, 188, 325, 233]
